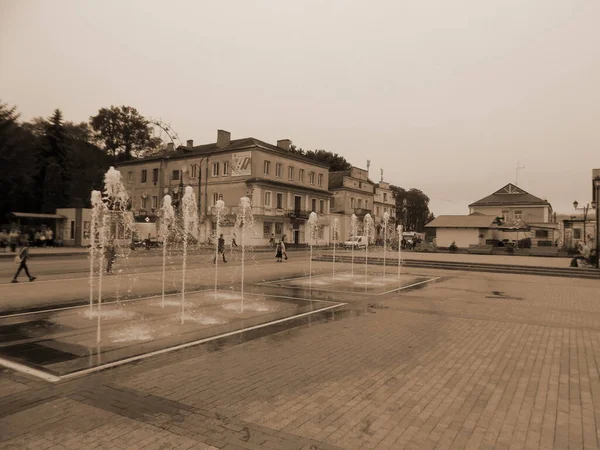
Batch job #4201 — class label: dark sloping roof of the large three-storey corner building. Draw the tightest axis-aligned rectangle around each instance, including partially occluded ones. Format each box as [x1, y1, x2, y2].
[118, 137, 329, 168]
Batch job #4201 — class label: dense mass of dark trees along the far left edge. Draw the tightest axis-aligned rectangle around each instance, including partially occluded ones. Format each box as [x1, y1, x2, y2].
[0, 103, 110, 221]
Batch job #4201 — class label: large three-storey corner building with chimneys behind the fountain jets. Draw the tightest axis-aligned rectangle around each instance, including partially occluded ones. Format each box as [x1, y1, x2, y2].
[119, 130, 331, 245]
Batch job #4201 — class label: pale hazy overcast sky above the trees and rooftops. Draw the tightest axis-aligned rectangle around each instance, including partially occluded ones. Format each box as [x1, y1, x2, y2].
[0, 0, 600, 215]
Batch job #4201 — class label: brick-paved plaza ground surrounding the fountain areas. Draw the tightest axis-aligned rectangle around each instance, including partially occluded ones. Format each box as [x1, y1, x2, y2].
[0, 255, 600, 450]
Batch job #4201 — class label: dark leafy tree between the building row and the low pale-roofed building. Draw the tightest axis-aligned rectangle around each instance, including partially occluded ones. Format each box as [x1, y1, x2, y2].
[390, 185, 433, 233]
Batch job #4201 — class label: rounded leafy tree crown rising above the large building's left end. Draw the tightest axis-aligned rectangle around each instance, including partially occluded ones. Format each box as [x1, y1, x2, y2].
[90, 106, 160, 162]
